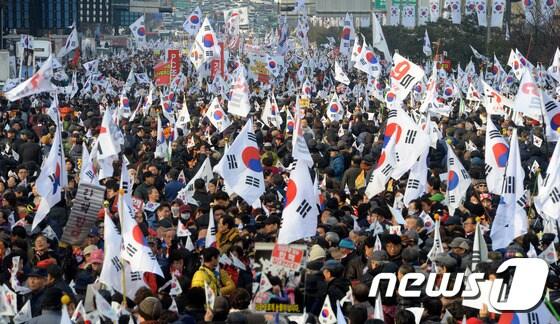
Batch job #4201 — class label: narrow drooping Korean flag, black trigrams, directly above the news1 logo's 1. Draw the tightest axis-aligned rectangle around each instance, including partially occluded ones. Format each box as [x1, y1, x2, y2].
[490, 129, 528, 250]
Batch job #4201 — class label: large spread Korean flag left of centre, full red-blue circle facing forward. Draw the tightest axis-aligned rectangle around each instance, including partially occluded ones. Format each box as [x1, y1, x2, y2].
[214, 119, 265, 204]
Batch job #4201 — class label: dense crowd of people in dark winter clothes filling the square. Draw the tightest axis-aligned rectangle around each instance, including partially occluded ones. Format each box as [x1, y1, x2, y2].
[0, 26, 560, 324]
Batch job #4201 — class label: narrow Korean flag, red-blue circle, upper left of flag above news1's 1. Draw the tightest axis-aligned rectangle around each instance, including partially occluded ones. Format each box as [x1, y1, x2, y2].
[484, 118, 509, 195]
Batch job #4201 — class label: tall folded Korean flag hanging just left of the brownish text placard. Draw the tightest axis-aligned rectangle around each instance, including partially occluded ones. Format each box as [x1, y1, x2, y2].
[32, 115, 68, 228]
